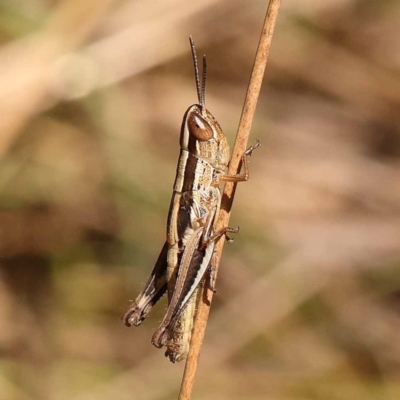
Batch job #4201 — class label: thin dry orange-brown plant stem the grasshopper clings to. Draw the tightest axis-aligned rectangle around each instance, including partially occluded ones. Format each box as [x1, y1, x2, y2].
[179, 0, 281, 400]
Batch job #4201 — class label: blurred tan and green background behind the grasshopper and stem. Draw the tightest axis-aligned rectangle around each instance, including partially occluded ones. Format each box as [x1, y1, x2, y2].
[0, 0, 400, 400]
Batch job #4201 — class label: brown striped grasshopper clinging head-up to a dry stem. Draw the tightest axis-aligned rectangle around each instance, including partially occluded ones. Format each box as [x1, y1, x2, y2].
[122, 37, 260, 362]
